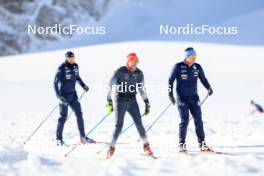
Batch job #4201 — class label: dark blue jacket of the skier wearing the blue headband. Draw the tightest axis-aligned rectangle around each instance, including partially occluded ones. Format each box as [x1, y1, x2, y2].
[169, 62, 211, 98]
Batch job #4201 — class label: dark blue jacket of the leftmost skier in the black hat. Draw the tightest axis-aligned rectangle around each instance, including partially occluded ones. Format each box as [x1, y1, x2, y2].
[54, 61, 86, 96]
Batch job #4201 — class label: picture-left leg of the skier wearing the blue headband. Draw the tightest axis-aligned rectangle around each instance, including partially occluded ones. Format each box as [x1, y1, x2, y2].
[177, 99, 189, 144]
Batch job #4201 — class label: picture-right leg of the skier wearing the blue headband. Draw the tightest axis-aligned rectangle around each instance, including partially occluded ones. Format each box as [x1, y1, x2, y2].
[190, 100, 205, 144]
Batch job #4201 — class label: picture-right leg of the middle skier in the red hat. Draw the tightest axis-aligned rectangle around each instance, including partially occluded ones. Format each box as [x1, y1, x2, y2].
[128, 101, 148, 143]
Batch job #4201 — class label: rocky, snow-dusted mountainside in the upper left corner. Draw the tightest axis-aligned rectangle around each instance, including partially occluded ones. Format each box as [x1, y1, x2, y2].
[0, 0, 110, 55]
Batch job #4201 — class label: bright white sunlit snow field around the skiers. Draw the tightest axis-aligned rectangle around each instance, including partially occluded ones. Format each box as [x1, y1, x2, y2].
[0, 42, 264, 176]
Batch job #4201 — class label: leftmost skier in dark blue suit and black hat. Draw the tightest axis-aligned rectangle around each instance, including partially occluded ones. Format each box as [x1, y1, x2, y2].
[54, 51, 94, 146]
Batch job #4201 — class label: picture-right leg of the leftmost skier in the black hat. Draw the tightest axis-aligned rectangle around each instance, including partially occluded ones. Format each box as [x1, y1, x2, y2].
[70, 95, 85, 137]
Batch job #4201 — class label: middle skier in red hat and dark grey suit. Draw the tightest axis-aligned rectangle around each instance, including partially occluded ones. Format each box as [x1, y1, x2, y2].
[107, 53, 153, 158]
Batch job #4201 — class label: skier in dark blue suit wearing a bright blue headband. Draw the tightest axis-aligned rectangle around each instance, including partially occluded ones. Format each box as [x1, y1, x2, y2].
[169, 47, 213, 152]
